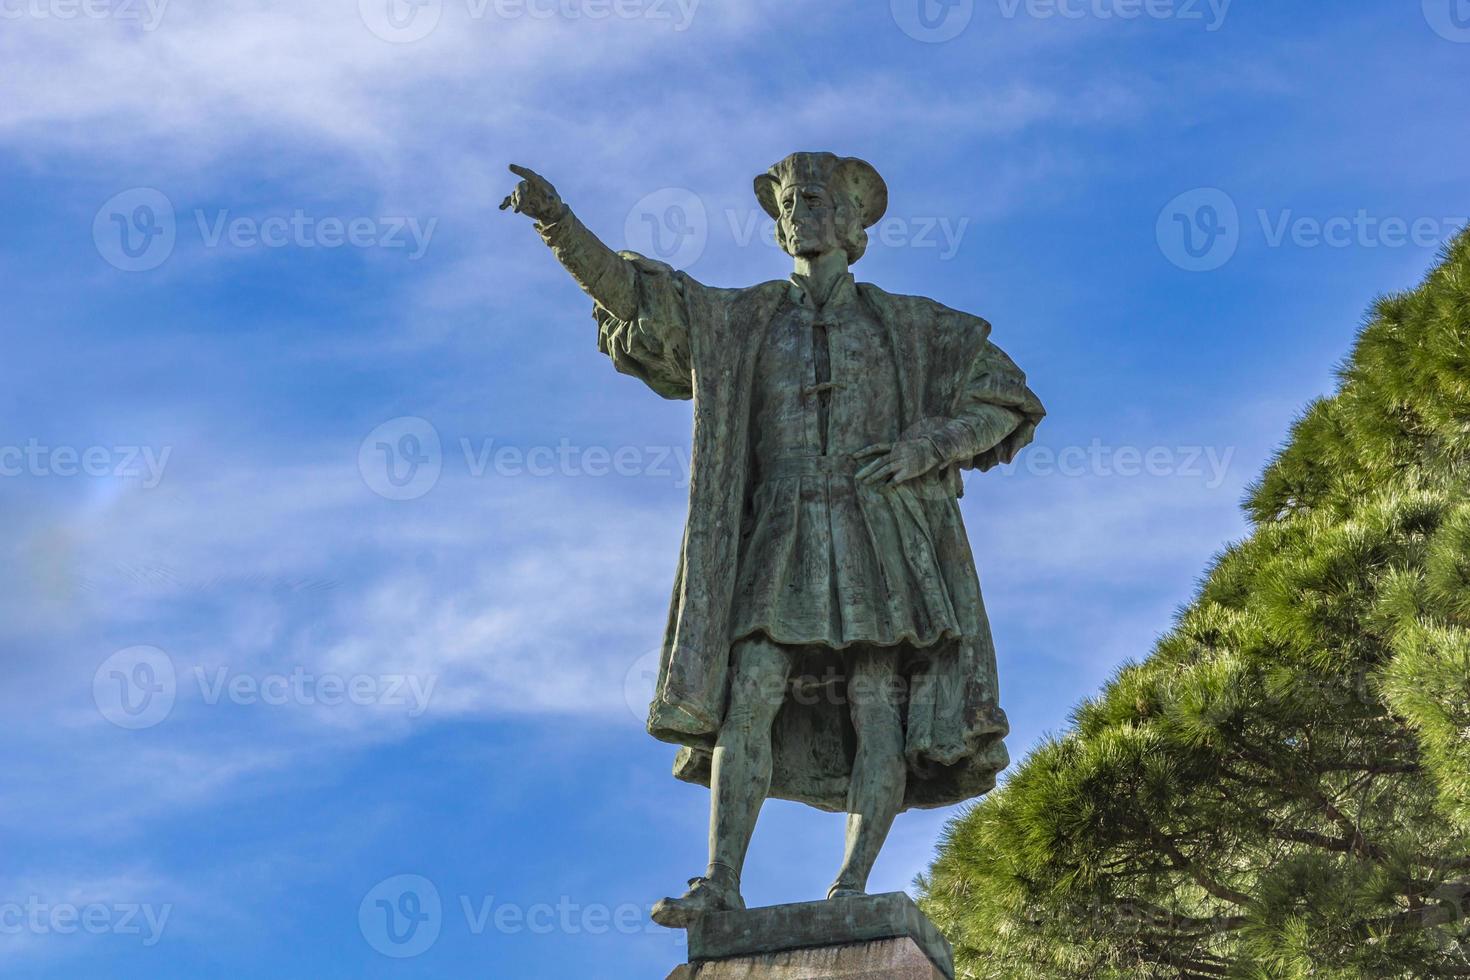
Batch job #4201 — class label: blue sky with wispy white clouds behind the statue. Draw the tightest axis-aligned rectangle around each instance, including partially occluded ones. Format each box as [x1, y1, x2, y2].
[0, 0, 1470, 980]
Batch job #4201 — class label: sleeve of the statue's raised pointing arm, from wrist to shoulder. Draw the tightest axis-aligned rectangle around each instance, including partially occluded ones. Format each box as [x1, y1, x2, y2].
[538, 212, 697, 398]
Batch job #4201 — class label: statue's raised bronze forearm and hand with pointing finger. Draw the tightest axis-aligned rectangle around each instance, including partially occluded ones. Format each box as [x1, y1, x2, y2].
[500, 163, 638, 320]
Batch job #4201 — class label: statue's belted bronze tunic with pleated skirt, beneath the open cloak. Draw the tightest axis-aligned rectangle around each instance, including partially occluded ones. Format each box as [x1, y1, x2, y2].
[732, 275, 1019, 649]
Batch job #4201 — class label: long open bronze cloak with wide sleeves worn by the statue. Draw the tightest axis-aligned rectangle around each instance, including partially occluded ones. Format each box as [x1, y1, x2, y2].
[594, 253, 1045, 811]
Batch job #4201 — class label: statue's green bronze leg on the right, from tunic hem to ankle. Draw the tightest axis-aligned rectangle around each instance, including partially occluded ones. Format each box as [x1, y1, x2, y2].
[829, 648, 908, 895]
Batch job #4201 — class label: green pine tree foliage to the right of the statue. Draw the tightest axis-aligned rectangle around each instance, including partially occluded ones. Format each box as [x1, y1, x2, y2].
[919, 234, 1470, 980]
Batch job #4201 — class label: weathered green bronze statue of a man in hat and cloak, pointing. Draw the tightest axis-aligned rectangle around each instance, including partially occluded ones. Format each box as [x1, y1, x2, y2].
[501, 153, 1045, 927]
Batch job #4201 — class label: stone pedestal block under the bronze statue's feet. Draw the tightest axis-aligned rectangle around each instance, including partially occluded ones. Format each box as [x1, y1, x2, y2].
[669, 892, 954, 980]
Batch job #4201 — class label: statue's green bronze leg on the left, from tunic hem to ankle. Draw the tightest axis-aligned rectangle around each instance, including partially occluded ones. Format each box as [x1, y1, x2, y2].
[707, 638, 792, 892]
